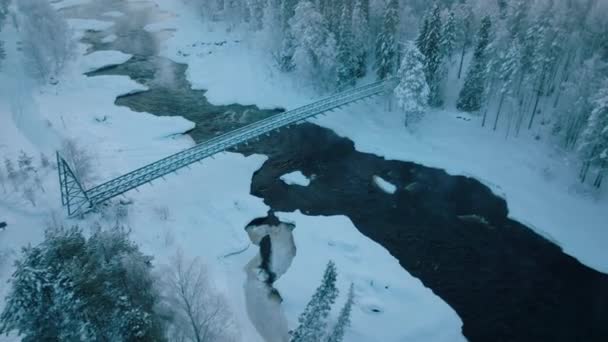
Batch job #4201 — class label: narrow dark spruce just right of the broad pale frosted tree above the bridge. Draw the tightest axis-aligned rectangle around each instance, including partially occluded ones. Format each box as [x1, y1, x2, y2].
[336, 6, 359, 90]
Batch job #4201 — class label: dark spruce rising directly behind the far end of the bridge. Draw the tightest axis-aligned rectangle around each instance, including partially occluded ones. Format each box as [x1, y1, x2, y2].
[376, 0, 399, 80]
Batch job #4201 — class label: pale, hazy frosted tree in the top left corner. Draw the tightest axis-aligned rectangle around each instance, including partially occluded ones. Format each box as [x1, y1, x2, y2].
[17, 0, 75, 82]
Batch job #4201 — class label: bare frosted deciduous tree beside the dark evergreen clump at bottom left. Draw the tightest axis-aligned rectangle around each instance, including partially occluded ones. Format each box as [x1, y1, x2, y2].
[162, 252, 237, 342]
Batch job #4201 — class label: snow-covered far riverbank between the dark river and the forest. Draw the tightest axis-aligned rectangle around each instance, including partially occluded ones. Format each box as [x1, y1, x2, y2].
[148, 0, 608, 273]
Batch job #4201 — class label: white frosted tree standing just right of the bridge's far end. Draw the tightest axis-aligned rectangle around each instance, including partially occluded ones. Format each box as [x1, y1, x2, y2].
[394, 42, 429, 126]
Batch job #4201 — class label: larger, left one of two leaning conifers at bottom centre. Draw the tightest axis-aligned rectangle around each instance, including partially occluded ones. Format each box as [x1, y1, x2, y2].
[291, 261, 338, 342]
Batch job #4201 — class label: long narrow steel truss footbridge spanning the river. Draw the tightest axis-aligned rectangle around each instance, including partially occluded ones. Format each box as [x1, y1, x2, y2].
[57, 79, 396, 216]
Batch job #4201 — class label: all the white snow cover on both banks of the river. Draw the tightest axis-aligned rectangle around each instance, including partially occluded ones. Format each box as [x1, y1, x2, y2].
[0, 0, 608, 342]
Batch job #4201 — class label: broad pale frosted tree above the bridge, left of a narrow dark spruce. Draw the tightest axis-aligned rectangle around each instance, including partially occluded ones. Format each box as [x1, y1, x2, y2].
[289, 1, 336, 86]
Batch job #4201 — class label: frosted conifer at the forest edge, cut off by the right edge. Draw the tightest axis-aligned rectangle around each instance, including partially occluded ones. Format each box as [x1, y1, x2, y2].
[580, 81, 608, 188]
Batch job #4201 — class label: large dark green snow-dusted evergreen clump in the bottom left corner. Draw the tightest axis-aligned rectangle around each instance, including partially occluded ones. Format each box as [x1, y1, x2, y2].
[0, 227, 164, 341]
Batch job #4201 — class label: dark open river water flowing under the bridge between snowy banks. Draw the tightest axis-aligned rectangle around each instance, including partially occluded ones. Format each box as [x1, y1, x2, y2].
[66, 1, 608, 342]
